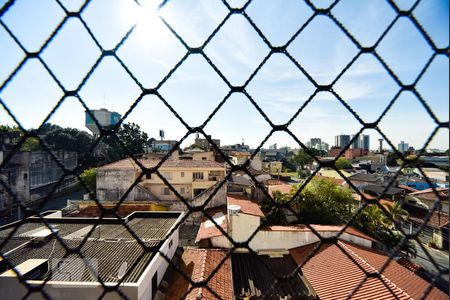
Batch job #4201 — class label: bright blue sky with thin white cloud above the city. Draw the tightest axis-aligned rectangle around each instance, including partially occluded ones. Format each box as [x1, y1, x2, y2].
[0, 0, 449, 149]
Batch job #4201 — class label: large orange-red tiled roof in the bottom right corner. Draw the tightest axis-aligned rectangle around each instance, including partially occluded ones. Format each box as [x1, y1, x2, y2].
[291, 241, 448, 300]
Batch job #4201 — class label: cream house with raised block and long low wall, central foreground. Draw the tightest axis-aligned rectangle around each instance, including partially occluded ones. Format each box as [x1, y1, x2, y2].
[196, 195, 376, 253]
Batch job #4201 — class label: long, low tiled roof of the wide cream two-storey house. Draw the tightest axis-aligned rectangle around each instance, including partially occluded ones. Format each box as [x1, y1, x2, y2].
[99, 158, 225, 170]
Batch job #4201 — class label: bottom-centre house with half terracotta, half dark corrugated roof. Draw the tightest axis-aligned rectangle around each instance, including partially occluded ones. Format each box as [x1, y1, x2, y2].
[166, 248, 318, 300]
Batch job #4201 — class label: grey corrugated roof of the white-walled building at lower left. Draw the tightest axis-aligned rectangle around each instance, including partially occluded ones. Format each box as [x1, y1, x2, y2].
[0, 212, 181, 282]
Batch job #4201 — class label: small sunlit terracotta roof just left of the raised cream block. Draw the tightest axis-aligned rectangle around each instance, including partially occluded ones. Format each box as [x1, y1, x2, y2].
[195, 207, 228, 242]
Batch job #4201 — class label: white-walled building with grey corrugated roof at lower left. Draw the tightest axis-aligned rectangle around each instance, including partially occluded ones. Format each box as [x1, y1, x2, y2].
[0, 211, 183, 299]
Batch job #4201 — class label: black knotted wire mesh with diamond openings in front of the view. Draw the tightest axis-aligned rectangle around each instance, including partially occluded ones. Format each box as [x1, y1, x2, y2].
[0, 0, 449, 299]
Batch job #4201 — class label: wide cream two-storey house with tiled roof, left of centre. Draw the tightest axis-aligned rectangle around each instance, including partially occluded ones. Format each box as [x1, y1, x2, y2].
[97, 158, 226, 206]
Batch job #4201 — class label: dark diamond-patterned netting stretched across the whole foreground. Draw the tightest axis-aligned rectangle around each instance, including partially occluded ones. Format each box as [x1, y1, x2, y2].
[0, 0, 449, 299]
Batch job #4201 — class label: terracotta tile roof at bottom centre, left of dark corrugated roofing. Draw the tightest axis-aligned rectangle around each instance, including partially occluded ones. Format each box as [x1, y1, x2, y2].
[166, 249, 233, 300]
